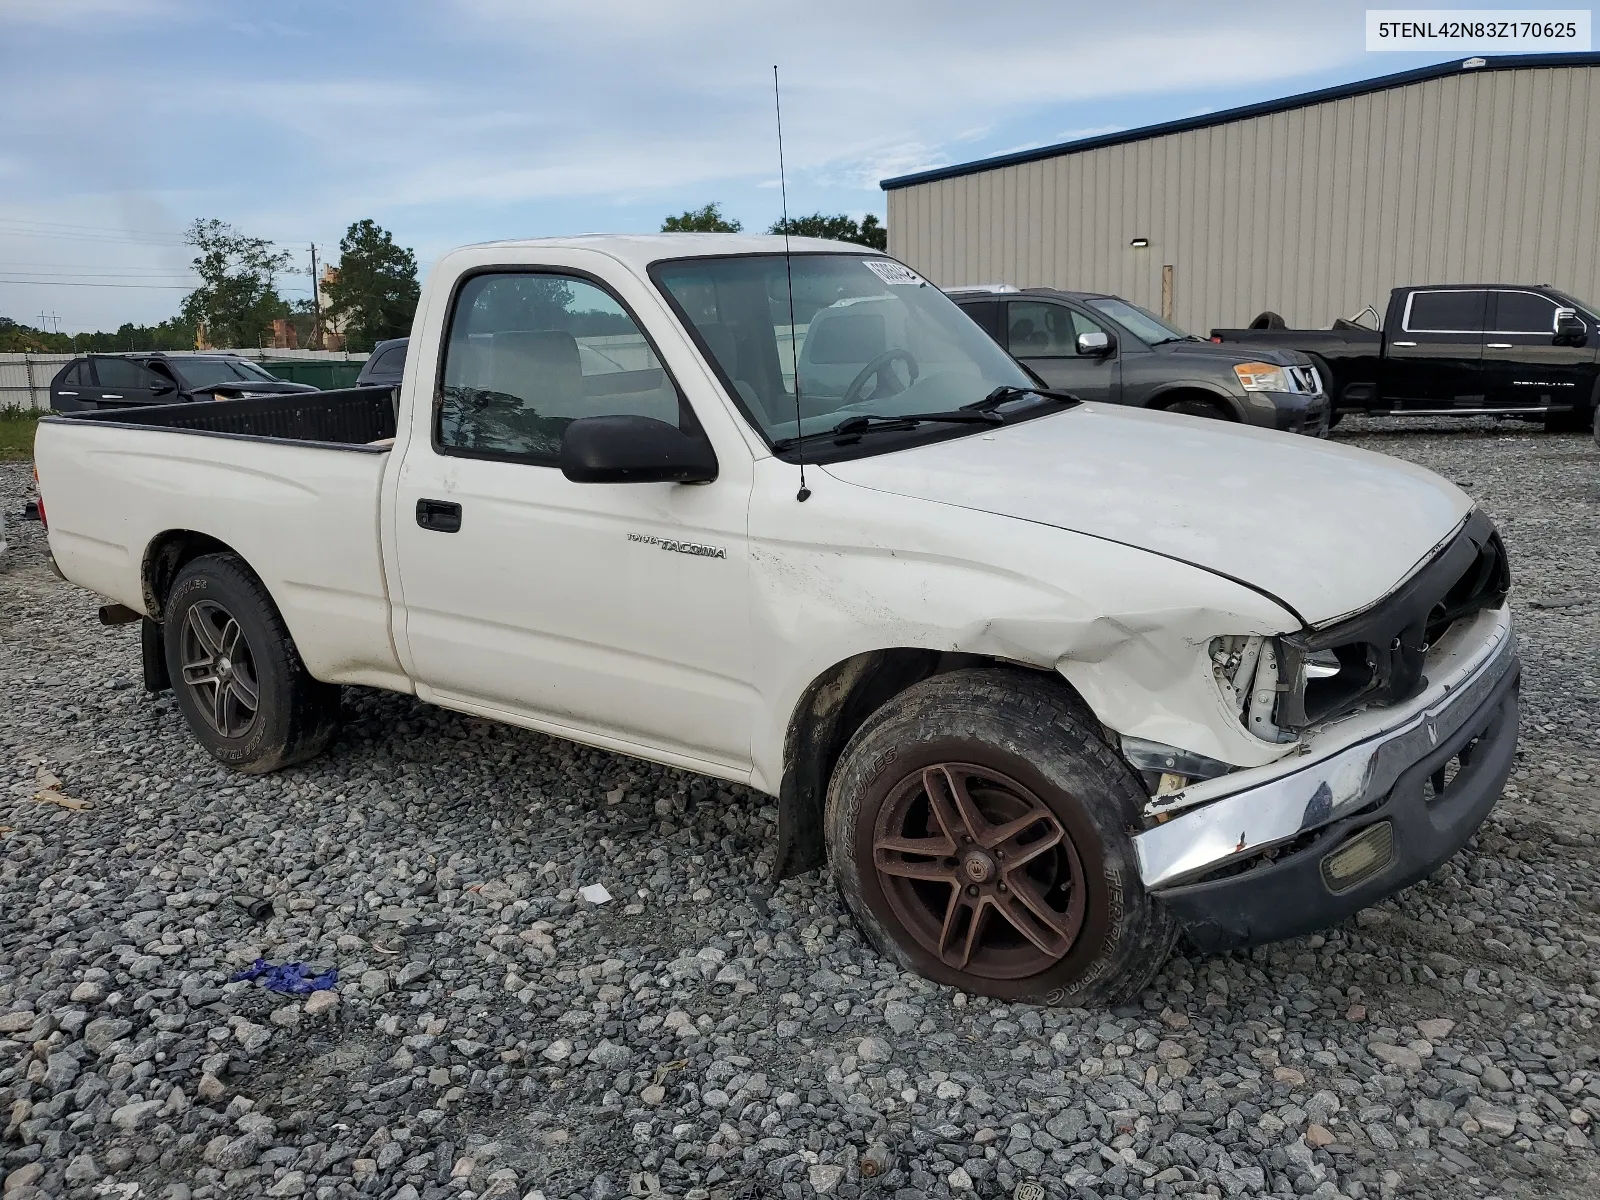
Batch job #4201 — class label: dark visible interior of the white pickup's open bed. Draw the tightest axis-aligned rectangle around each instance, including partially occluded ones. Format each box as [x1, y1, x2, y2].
[61, 387, 395, 450]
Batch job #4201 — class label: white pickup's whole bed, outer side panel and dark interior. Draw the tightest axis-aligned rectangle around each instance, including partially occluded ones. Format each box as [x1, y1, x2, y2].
[34, 387, 410, 691]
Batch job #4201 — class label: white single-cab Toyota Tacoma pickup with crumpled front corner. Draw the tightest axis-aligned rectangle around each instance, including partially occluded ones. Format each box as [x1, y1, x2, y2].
[37, 235, 1518, 1005]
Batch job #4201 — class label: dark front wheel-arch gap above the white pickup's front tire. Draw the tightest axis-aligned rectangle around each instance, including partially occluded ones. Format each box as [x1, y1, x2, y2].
[773, 646, 1098, 880]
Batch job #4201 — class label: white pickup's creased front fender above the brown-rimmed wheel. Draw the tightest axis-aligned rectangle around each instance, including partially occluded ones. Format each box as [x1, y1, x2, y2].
[750, 464, 1299, 794]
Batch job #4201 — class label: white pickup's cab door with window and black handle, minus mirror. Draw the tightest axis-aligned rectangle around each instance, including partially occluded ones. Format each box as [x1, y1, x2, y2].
[390, 269, 755, 774]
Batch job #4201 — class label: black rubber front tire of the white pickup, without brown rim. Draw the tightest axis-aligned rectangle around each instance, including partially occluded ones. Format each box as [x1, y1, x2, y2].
[826, 667, 1178, 1006]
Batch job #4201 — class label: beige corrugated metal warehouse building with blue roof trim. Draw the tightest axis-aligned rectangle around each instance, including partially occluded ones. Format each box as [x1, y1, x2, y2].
[883, 53, 1600, 333]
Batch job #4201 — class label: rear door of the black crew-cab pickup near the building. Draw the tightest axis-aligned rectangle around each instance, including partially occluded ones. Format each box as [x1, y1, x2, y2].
[1382, 288, 1488, 410]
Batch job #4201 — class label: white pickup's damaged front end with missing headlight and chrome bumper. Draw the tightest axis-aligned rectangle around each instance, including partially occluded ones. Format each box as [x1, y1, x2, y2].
[1123, 512, 1518, 946]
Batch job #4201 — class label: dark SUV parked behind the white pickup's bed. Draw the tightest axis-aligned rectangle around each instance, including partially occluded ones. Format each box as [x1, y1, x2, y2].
[50, 354, 317, 413]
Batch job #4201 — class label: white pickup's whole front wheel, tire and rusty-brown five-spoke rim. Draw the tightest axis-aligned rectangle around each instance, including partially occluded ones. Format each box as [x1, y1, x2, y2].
[827, 669, 1178, 1006]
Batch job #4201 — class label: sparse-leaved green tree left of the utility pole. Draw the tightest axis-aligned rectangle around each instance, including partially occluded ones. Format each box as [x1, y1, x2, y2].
[182, 218, 290, 347]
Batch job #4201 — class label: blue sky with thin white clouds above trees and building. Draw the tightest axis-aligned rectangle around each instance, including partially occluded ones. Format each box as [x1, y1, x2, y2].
[0, 0, 1574, 331]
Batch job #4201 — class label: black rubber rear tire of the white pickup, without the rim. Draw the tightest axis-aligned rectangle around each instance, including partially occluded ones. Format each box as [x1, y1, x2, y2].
[162, 554, 339, 774]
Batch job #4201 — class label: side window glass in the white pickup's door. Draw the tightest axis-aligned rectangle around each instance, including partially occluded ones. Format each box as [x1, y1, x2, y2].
[435, 272, 693, 466]
